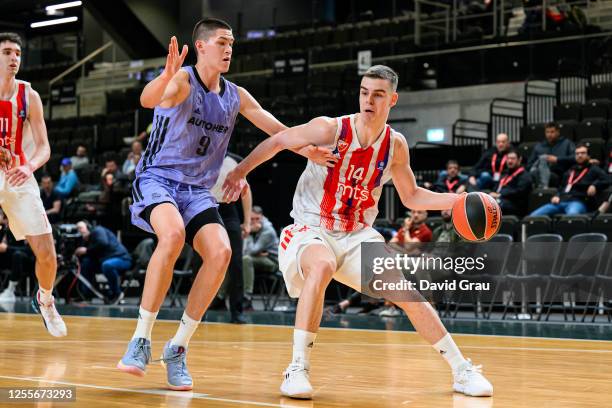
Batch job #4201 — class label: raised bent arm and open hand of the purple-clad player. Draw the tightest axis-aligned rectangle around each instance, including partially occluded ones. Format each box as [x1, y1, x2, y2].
[140, 37, 189, 109]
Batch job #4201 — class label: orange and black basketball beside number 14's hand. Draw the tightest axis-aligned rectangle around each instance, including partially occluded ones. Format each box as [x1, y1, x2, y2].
[453, 192, 501, 241]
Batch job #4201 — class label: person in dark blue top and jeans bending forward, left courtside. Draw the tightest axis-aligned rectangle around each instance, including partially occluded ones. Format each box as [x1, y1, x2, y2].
[75, 221, 132, 304]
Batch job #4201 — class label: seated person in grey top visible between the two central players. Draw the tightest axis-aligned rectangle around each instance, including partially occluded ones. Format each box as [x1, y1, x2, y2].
[242, 205, 278, 300]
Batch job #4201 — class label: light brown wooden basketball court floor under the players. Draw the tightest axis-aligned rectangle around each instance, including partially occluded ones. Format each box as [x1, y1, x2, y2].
[0, 313, 612, 408]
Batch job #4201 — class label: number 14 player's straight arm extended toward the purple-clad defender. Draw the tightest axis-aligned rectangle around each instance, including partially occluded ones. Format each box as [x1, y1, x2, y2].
[223, 117, 337, 201]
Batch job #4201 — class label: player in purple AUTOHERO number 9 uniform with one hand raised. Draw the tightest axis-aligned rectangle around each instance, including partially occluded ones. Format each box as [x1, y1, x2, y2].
[117, 18, 335, 391]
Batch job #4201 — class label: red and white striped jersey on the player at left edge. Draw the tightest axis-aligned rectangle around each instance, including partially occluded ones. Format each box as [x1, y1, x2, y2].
[0, 80, 30, 167]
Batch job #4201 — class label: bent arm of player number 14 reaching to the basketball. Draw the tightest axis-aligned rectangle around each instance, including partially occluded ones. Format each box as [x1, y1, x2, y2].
[391, 134, 459, 210]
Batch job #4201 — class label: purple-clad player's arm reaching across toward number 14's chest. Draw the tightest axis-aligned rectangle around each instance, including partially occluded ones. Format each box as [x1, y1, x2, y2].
[238, 87, 337, 167]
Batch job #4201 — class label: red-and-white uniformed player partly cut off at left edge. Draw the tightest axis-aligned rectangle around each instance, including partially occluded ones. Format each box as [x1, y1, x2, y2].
[0, 33, 67, 337]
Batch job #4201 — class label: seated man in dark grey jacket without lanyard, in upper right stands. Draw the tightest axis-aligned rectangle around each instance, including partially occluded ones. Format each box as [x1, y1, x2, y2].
[527, 122, 576, 188]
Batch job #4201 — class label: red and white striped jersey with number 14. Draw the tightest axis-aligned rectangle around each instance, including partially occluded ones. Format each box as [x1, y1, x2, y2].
[291, 115, 393, 232]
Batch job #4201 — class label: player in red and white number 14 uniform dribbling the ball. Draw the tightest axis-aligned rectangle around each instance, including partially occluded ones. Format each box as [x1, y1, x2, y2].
[224, 65, 493, 398]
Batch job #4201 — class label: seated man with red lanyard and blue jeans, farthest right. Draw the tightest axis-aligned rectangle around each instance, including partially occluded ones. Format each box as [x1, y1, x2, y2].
[531, 143, 608, 215]
